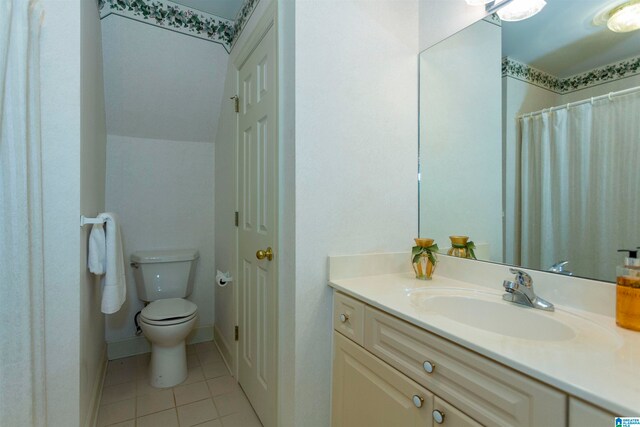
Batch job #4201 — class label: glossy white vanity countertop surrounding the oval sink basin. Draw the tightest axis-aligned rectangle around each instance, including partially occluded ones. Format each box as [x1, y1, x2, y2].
[329, 273, 640, 416]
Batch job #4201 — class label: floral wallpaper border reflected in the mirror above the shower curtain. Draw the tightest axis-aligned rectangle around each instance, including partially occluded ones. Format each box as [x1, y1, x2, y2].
[502, 56, 640, 94]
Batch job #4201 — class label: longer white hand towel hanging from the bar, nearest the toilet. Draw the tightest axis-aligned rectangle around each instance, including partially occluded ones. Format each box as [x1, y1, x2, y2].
[98, 212, 127, 314]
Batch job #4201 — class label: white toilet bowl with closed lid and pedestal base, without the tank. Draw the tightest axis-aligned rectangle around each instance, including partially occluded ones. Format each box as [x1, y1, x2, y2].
[139, 298, 198, 388]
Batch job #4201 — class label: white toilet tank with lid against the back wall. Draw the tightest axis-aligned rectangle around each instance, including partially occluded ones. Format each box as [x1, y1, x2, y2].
[131, 249, 200, 301]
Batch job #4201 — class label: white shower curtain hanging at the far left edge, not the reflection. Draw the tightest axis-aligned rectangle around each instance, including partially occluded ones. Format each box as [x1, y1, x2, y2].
[0, 0, 46, 426]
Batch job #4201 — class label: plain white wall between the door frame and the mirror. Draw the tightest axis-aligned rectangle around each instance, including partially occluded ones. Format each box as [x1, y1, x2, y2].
[296, 0, 418, 426]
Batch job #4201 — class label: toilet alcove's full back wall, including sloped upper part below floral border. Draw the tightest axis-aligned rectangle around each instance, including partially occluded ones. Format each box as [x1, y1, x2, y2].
[102, 15, 228, 357]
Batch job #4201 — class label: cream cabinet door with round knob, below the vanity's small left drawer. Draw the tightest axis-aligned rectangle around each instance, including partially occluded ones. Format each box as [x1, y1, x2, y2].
[331, 332, 433, 427]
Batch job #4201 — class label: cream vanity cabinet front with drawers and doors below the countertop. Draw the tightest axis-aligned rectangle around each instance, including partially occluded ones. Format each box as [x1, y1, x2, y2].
[332, 293, 567, 427]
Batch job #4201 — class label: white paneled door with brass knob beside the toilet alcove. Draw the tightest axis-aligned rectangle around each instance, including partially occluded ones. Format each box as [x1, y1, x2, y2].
[238, 26, 278, 427]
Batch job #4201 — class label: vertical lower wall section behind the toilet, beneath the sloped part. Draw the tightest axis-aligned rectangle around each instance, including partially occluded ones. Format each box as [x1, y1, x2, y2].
[106, 135, 215, 342]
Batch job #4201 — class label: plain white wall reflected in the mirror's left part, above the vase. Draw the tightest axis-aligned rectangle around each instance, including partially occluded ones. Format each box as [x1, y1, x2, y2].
[420, 21, 502, 262]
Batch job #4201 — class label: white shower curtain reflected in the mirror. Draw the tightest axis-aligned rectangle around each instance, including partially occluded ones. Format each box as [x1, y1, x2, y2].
[518, 92, 640, 281]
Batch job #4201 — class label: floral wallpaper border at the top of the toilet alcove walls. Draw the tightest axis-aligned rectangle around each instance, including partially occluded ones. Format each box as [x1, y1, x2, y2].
[97, 0, 260, 52]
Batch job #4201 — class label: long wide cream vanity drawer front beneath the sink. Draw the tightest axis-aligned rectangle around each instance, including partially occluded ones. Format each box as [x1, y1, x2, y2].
[365, 307, 566, 427]
